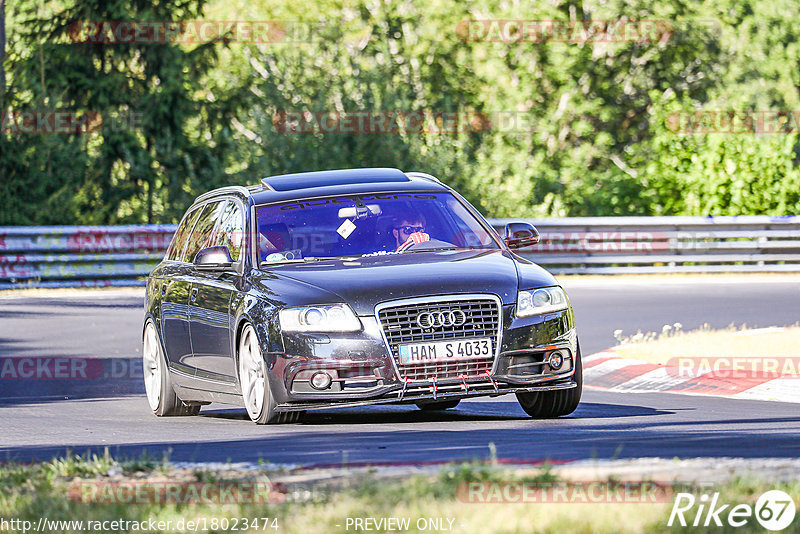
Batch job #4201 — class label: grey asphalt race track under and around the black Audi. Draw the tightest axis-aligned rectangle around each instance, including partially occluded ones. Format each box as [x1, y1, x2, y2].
[0, 276, 800, 466]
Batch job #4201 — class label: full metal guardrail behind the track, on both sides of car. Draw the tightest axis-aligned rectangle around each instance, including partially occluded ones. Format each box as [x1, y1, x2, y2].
[0, 216, 800, 289]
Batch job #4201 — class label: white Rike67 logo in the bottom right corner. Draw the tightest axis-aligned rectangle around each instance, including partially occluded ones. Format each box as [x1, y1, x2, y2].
[667, 490, 795, 531]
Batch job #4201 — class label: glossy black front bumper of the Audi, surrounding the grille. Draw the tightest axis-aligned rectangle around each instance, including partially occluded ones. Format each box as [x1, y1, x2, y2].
[271, 306, 577, 411]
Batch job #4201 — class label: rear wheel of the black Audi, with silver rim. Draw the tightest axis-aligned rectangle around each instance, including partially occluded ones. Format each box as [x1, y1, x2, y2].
[142, 319, 200, 417]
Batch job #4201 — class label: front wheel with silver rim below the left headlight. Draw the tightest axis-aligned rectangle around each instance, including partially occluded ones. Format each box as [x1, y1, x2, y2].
[237, 324, 305, 425]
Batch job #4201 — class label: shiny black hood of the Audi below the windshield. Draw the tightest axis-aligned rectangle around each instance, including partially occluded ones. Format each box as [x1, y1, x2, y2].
[256, 250, 555, 315]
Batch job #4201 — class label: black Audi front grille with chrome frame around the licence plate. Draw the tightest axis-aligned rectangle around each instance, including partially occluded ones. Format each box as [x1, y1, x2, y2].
[378, 297, 500, 380]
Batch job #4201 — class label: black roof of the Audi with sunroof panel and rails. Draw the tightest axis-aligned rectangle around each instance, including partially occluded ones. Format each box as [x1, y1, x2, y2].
[195, 168, 450, 204]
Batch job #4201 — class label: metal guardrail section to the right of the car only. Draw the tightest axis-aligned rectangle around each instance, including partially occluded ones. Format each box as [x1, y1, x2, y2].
[500, 215, 800, 274]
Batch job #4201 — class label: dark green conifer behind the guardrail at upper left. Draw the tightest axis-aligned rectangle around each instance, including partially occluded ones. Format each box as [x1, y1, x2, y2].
[0, 0, 247, 224]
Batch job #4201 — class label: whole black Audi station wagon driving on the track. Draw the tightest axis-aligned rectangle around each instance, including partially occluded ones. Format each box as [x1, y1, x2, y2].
[143, 169, 582, 424]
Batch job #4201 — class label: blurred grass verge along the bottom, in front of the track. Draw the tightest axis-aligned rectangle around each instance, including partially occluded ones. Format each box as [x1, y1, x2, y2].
[0, 456, 800, 534]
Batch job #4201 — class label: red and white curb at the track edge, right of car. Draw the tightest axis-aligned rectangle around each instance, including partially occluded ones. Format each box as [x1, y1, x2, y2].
[583, 349, 800, 403]
